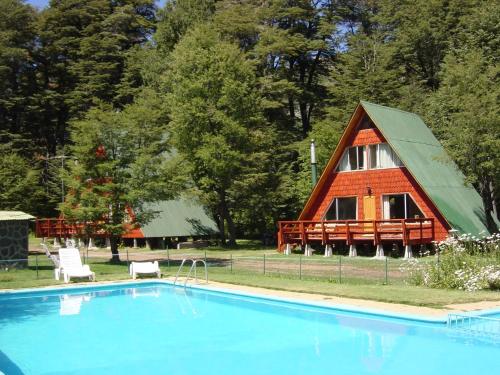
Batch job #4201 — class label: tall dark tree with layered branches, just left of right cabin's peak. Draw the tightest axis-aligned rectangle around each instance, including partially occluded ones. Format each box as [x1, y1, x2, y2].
[215, 0, 337, 138]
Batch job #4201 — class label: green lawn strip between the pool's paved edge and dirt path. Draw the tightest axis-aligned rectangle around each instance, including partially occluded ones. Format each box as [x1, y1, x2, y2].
[0, 253, 500, 308]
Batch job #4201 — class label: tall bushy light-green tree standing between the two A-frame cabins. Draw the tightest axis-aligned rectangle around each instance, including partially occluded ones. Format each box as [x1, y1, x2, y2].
[164, 25, 269, 245]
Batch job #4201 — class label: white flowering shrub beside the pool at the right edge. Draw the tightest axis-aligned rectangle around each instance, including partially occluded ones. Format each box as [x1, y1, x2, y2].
[400, 233, 500, 292]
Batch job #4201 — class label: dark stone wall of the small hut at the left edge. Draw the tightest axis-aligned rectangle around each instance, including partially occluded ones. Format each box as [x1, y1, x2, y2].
[0, 220, 28, 268]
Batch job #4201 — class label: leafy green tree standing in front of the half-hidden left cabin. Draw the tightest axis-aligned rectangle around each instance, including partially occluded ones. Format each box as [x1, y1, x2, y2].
[60, 91, 173, 261]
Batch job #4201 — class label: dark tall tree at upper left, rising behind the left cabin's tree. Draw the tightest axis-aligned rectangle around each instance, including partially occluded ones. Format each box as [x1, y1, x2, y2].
[38, 0, 155, 154]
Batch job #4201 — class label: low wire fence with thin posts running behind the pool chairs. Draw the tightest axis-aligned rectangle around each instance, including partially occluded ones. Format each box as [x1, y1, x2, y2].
[0, 249, 422, 288]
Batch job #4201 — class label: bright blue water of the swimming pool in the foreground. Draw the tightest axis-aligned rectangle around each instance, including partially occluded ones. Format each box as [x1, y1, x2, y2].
[0, 283, 500, 375]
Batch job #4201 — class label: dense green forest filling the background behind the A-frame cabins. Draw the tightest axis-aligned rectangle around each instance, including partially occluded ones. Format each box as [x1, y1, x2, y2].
[0, 0, 500, 244]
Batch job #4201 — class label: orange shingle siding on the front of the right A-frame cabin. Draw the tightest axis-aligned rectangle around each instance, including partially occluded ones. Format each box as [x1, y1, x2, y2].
[303, 129, 449, 241]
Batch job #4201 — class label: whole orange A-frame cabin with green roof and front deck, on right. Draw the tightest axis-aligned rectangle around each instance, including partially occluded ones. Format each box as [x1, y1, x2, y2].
[278, 101, 494, 257]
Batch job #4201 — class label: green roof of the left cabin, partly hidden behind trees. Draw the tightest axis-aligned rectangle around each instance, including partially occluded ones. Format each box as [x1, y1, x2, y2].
[141, 198, 218, 238]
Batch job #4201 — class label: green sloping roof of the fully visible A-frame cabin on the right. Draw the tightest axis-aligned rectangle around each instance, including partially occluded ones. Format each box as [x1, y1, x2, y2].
[361, 101, 496, 235]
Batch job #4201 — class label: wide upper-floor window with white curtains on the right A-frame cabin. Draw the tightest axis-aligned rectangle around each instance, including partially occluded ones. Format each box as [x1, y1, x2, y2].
[336, 143, 403, 172]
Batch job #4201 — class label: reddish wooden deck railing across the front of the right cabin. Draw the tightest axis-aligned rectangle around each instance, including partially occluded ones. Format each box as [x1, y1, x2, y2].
[278, 218, 435, 250]
